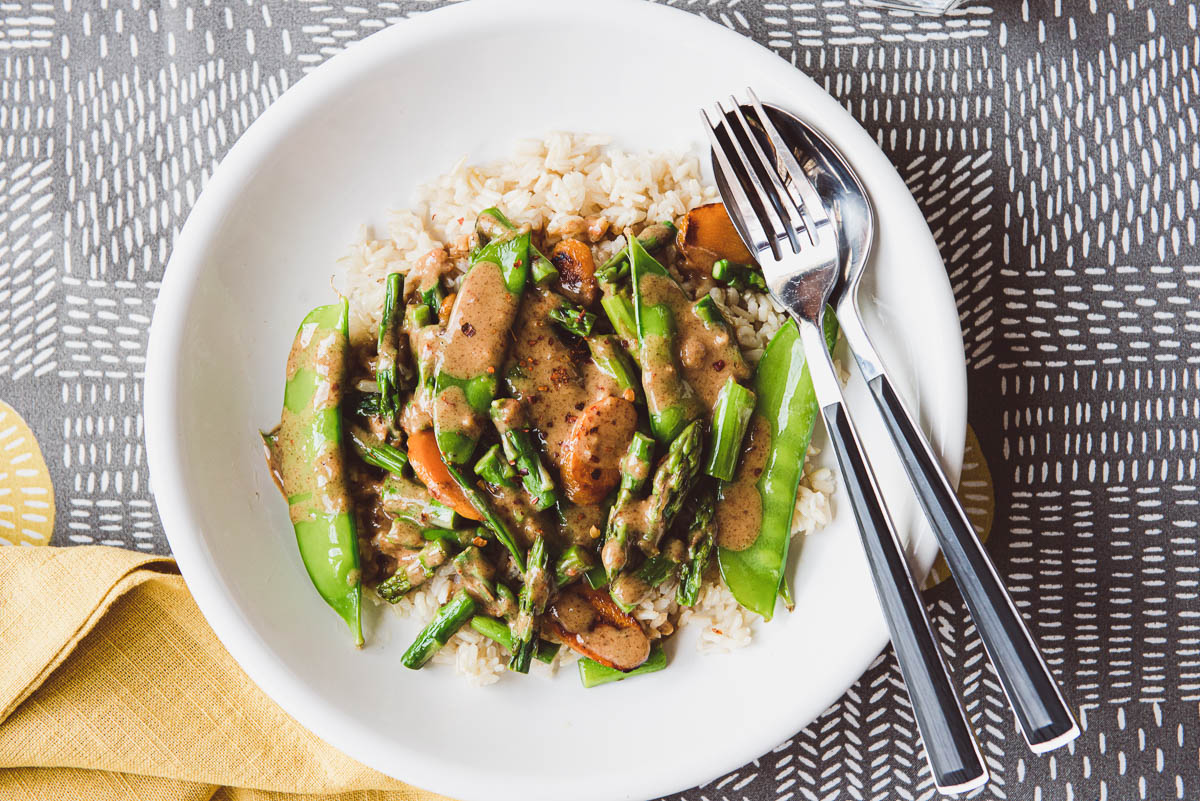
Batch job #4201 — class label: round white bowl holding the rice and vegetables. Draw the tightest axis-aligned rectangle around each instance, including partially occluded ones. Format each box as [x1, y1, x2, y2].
[146, 0, 966, 801]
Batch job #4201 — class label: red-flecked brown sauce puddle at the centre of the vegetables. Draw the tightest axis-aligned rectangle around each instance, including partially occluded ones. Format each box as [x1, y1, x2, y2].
[504, 289, 617, 475]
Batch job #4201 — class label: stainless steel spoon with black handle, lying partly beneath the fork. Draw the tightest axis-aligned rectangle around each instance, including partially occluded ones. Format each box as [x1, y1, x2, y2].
[761, 98, 1079, 753]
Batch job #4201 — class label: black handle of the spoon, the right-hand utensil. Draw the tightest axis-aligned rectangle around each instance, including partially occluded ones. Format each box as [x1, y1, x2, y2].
[868, 374, 1079, 753]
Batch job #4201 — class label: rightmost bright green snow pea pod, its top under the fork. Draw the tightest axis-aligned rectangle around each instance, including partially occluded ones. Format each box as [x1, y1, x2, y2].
[718, 311, 838, 620]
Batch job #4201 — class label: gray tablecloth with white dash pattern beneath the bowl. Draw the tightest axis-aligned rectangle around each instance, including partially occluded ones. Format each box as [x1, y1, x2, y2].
[0, 0, 1200, 801]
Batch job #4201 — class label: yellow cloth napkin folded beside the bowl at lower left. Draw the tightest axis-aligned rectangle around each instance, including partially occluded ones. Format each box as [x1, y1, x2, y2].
[0, 546, 451, 801]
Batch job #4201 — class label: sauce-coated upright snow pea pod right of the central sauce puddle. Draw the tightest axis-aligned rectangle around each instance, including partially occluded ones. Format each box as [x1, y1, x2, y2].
[629, 231, 706, 442]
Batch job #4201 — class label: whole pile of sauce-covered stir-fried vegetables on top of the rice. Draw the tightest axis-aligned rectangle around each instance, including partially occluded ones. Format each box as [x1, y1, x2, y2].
[264, 204, 835, 687]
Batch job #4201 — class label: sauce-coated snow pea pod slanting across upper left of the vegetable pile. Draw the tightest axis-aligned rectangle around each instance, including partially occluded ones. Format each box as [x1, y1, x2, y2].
[433, 225, 529, 465]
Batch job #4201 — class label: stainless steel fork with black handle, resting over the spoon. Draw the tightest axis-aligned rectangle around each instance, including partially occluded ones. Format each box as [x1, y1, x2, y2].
[701, 95, 988, 793]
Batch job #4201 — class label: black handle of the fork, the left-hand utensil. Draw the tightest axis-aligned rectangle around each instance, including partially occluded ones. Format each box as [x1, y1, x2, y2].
[821, 401, 988, 793]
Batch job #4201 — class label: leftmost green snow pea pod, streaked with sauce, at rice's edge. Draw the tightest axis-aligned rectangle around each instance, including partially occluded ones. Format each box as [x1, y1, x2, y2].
[270, 299, 362, 645]
